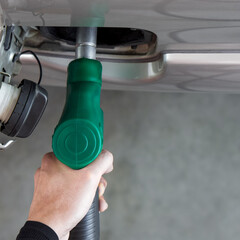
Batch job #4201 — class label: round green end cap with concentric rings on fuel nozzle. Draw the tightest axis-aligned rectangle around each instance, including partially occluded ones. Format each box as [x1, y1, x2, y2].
[52, 119, 103, 169]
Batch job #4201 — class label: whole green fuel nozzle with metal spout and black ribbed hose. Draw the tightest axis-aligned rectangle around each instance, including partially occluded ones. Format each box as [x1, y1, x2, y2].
[52, 27, 103, 240]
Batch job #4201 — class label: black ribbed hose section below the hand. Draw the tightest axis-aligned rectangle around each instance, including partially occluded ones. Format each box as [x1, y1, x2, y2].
[69, 190, 100, 240]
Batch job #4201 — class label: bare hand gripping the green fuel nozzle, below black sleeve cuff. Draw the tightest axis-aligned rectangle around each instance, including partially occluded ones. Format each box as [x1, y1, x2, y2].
[28, 150, 113, 240]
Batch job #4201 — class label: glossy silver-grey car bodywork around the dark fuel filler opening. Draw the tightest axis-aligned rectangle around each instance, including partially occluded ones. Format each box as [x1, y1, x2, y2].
[0, 0, 240, 93]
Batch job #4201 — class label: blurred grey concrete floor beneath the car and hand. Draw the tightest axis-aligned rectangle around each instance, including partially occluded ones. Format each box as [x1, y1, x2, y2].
[0, 88, 240, 240]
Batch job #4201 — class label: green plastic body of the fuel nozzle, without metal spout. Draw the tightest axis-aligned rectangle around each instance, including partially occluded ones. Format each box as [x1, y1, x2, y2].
[52, 58, 103, 169]
